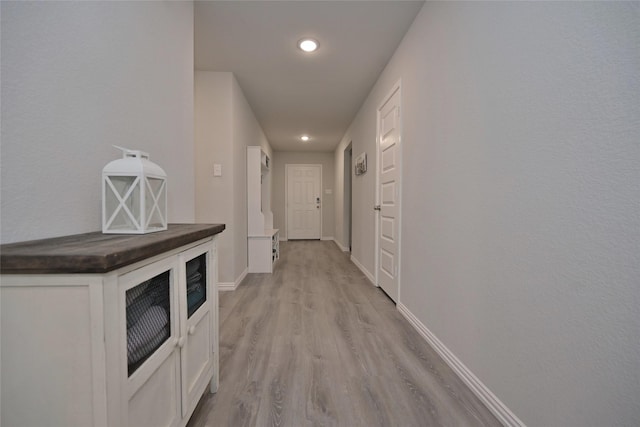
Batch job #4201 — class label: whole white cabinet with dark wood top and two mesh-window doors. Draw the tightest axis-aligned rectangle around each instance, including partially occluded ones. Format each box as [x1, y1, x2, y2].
[0, 225, 224, 427]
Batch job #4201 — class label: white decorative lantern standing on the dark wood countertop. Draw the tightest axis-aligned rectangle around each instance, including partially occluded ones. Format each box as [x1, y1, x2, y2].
[102, 147, 167, 234]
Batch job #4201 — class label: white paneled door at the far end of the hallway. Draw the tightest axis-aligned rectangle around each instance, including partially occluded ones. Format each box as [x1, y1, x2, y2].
[286, 165, 322, 240]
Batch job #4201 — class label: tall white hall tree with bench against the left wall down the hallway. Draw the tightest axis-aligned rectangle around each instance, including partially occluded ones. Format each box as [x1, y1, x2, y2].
[247, 147, 280, 273]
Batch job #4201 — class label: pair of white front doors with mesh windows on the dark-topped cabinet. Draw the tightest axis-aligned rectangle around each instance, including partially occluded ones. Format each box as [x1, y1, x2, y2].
[118, 243, 217, 427]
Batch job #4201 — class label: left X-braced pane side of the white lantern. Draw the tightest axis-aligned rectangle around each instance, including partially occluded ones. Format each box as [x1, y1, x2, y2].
[105, 176, 140, 230]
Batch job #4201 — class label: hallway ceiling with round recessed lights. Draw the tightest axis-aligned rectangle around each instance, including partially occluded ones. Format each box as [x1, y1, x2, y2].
[194, 0, 423, 151]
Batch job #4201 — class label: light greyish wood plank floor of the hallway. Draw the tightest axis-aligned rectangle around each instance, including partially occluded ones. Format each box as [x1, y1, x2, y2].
[188, 241, 500, 427]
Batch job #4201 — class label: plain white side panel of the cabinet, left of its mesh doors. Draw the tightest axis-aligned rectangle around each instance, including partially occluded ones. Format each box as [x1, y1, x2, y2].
[0, 284, 100, 426]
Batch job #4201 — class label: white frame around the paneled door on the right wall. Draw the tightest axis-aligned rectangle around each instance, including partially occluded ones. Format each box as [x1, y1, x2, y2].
[373, 79, 403, 304]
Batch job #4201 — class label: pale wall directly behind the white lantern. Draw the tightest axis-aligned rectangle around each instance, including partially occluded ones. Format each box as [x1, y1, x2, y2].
[0, 1, 194, 243]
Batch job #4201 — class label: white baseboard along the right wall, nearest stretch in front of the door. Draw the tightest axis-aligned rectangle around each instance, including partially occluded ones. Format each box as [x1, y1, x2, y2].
[397, 303, 526, 427]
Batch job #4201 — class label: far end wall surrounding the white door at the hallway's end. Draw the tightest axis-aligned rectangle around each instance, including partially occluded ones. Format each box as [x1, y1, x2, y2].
[271, 151, 335, 240]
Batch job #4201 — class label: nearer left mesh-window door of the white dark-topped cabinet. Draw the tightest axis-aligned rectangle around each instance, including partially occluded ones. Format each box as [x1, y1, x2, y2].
[120, 256, 182, 426]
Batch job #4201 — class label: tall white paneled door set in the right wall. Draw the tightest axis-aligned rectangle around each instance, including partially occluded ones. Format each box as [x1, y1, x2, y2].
[375, 85, 401, 302]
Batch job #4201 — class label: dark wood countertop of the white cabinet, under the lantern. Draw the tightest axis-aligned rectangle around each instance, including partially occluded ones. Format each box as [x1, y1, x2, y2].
[0, 224, 225, 274]
